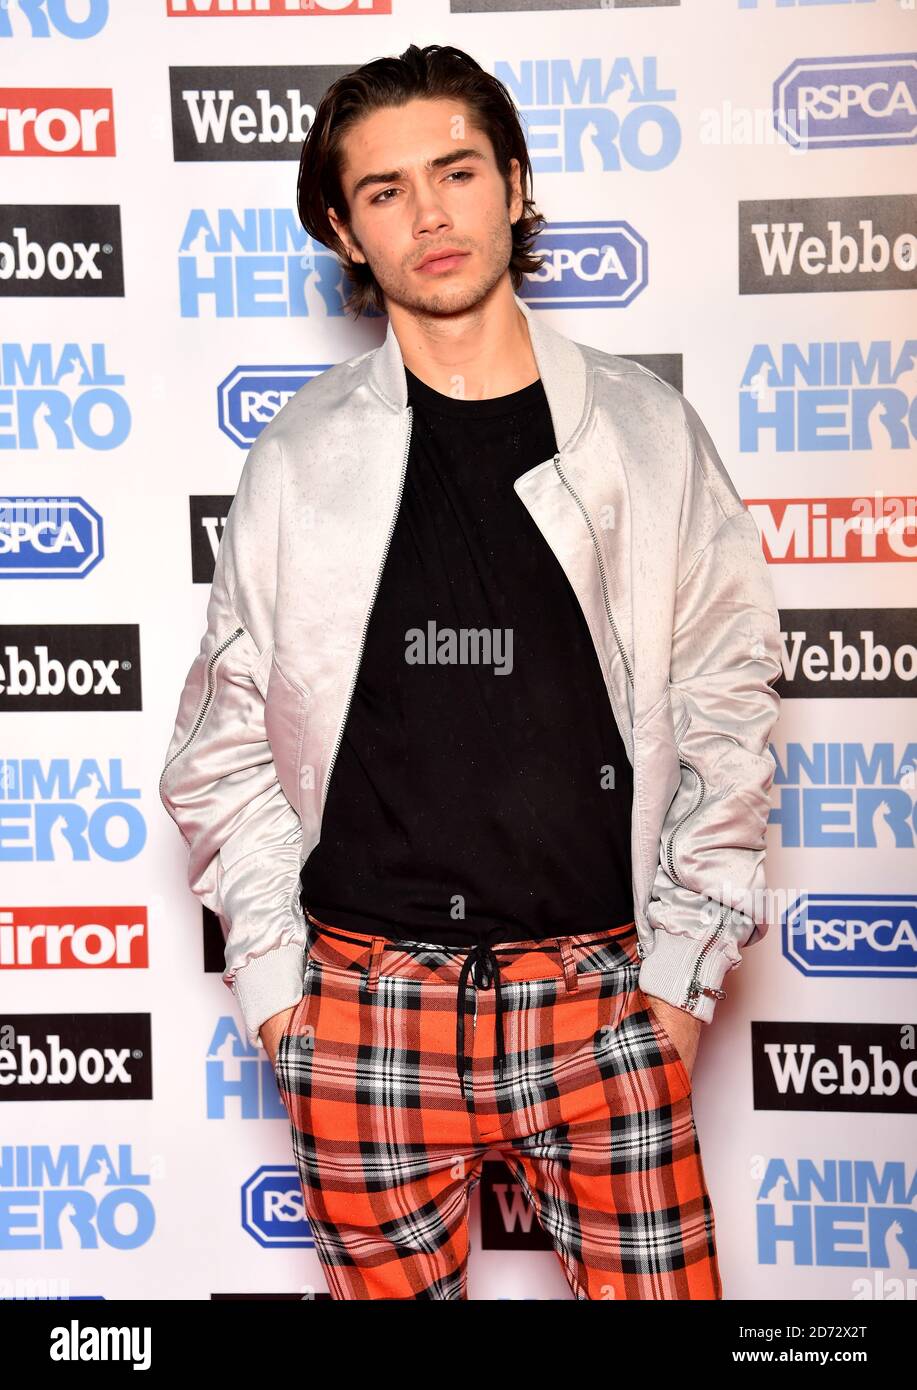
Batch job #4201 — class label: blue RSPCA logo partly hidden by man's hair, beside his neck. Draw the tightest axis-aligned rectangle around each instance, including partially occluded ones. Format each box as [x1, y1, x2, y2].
[520, 222, 649, 309]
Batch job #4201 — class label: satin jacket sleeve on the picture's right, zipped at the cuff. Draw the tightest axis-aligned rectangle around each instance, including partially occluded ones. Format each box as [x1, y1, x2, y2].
[639, 398, 782, 1023]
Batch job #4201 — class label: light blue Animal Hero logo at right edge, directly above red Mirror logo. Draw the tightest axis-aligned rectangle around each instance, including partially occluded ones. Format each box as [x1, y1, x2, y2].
[739, 338, 917, 453]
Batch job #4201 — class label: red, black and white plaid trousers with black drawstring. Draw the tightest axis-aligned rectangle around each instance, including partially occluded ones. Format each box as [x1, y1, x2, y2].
[275, 913, 722, 1298]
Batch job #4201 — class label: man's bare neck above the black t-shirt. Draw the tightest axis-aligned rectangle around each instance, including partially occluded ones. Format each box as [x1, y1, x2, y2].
[388, 275, 539, 400]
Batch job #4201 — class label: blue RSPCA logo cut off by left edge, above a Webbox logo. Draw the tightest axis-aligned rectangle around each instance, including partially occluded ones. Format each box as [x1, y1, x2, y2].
[0, 498, 104, 580]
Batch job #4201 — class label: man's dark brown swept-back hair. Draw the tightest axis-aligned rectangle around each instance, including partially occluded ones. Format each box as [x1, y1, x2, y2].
[296, 43, 545, 317]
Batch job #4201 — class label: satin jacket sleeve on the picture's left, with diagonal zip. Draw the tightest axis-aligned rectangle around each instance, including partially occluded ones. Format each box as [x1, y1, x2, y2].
[160, 435, 306, 1047]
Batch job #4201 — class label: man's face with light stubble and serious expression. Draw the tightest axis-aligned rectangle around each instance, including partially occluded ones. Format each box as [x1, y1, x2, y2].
[328, 99, 522, 314]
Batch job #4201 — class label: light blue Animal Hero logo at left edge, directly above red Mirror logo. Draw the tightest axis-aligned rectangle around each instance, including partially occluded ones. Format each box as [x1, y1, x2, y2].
[0, 758, 147, 863]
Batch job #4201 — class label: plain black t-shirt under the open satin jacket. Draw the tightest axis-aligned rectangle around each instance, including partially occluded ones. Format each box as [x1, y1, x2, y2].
[301, 358, 634, 945]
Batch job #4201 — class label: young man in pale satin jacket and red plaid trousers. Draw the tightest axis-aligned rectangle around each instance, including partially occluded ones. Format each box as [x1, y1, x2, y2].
[161, 46, 781, 1298]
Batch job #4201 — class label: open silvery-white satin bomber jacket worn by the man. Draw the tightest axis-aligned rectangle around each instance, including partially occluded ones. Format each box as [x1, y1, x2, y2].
[160, 296, 781, 1047]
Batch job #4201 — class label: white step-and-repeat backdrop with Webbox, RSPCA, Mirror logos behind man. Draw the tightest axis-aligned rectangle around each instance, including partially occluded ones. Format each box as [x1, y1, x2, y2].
[0, 0, 917, 1301]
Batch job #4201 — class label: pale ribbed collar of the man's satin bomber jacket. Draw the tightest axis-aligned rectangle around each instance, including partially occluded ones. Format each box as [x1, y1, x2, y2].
[370, 295, 586, 449]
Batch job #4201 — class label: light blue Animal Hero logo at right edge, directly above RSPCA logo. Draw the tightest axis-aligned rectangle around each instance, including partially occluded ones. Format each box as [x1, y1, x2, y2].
[768, 742, 917, 855]
